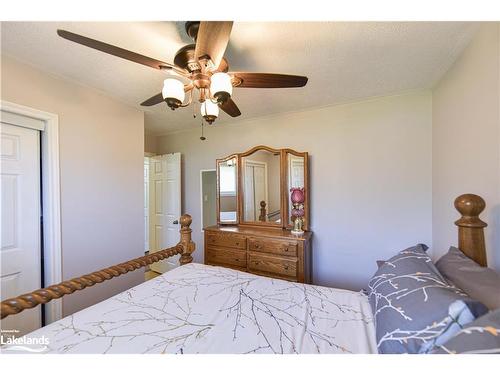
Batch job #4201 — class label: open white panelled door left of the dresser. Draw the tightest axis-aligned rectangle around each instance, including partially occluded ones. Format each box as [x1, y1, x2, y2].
[149, 153, 181, 273]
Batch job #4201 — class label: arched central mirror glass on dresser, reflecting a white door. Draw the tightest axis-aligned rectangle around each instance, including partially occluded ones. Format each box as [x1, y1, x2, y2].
[242, 150, 281, 224]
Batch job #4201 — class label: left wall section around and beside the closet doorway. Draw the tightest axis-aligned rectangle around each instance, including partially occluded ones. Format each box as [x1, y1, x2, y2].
[1, 56, 144, 315]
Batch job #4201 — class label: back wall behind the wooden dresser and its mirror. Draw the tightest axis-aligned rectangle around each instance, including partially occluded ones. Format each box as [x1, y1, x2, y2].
[158, 91, 434, 289]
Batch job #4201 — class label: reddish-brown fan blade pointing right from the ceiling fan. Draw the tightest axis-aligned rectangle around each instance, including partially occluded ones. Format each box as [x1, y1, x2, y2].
[229, 72, 307, 88]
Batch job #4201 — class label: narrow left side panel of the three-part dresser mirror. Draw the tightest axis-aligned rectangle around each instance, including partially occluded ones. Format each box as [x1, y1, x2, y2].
[217, 155, 238, 224]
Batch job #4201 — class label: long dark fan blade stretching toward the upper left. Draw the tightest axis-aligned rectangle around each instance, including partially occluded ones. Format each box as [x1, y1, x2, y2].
[57, 30, 186, 75]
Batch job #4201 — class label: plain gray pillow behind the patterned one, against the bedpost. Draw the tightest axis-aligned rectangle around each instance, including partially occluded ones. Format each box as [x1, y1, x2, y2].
[436, 247, 500, 310]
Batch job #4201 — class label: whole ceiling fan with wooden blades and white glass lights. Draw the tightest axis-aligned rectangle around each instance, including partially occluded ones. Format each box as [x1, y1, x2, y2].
[57, 21, 307, 124]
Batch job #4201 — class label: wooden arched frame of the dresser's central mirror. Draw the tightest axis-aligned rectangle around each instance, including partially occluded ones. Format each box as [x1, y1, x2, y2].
[238, 145, 284, 228]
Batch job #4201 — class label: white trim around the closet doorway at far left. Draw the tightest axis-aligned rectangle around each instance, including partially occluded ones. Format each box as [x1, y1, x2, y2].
[0, 100, 62, 324]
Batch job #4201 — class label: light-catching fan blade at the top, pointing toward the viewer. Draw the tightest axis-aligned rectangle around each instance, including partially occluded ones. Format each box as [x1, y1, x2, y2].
[194, 21, 233, 67]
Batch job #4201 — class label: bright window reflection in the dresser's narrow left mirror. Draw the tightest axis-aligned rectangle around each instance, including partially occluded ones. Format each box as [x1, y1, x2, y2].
[219, 158, 238, 223]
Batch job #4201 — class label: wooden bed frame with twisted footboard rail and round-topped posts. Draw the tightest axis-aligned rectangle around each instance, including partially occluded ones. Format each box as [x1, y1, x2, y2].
[0, 194, 487, 319]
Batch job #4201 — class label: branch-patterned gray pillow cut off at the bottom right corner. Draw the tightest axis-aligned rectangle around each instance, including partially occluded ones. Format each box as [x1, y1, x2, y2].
[432, 309, 500, 354]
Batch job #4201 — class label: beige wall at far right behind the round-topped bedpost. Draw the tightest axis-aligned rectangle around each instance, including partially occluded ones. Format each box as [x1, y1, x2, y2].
[432, 23, 500, 270]
